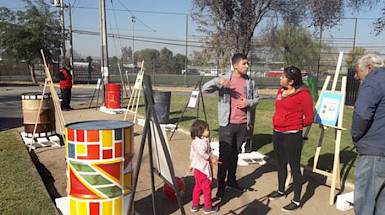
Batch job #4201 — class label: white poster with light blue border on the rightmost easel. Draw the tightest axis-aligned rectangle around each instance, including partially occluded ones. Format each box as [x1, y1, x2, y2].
[315, 92, 342, 126]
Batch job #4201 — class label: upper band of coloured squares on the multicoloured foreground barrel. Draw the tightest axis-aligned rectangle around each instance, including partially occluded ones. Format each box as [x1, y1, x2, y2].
[65, 126, 134, 161]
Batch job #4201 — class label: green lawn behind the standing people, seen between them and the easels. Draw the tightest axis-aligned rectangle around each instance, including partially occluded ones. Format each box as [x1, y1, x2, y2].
[125, 94, 356, 182]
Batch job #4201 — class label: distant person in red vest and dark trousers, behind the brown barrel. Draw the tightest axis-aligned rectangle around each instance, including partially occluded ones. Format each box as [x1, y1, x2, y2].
[58, 64, 73, 111]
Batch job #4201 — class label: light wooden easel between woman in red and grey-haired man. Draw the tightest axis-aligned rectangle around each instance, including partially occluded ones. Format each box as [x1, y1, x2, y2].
[285, 52, 347, 205]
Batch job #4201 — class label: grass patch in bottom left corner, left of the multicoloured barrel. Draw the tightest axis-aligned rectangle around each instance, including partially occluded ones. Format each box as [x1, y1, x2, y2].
[0, 130, 56, 215]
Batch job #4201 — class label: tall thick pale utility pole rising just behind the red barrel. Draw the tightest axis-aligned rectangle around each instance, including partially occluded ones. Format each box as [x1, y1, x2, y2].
[99, 0, 110, 85]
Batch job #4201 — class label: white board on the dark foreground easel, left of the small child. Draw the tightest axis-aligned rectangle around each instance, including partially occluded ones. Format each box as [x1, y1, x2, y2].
[150, 121, 174, 185]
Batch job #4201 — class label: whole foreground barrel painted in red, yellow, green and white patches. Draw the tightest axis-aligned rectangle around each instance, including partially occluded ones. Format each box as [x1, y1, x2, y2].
[65, 120, 134, 215]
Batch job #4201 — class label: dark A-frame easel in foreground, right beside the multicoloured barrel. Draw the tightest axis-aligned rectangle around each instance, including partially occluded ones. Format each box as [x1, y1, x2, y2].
[127, 74, 186, 215]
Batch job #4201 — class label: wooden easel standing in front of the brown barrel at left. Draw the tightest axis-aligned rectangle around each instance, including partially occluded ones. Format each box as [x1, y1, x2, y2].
[29, 49, 65, 148]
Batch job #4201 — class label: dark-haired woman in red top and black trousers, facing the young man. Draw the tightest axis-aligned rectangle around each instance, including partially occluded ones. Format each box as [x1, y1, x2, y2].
[269, 66, 314, 212]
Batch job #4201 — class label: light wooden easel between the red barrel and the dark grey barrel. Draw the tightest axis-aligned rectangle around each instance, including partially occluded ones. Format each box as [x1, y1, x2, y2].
[123, 61, 144, 123]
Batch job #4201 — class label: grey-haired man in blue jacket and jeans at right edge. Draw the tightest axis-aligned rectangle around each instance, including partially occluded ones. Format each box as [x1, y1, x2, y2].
[351, 54, 385, 215]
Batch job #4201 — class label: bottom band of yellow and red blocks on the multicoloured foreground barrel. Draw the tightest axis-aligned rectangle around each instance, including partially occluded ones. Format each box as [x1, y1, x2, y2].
[69, 197, 123, 215]
